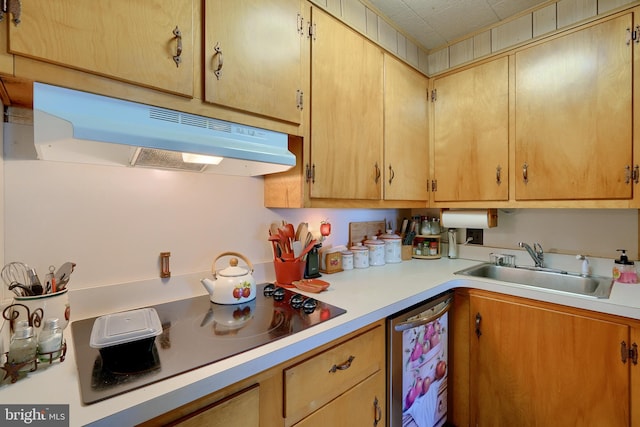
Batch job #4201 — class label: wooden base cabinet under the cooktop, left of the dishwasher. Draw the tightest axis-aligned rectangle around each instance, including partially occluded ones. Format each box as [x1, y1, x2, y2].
[140, 320, 386, 427]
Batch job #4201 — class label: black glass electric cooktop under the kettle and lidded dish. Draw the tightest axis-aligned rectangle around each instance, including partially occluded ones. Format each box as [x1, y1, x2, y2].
[71, 284, 346, 404]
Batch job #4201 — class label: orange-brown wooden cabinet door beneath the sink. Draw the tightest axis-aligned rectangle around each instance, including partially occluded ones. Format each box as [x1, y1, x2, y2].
[470, 295, 630, 426]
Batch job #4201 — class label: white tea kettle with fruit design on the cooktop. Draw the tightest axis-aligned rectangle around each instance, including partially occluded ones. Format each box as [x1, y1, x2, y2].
[200, 252, 256, 304]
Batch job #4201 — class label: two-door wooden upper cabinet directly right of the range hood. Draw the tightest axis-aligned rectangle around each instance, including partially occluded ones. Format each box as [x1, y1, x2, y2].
[264, 7, 429, 208]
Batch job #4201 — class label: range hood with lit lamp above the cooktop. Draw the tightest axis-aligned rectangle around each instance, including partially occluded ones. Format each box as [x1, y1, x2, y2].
[33, 83, 296, 176]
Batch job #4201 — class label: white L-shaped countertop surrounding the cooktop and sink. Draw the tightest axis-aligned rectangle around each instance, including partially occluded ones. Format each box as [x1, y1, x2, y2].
[0, 258, 640, 426]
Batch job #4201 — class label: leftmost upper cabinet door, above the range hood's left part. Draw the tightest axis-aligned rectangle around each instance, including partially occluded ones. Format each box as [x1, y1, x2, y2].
[9, 0, 194, 96]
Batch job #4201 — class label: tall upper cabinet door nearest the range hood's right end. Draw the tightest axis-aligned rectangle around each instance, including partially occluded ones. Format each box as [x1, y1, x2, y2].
[311, 8, 383, 200]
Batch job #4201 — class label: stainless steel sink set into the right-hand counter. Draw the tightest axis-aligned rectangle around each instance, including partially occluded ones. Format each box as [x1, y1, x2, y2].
[454, 263, 613, 298]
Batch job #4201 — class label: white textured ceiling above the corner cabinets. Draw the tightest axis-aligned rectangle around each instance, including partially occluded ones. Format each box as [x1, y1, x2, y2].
[368, 0, 549, 50]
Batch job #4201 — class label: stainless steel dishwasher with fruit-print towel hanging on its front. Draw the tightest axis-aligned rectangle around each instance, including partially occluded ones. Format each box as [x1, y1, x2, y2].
[387, 293, 453, 427]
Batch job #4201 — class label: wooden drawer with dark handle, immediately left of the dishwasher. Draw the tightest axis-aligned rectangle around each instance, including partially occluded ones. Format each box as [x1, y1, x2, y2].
[284, 326, 385, 425]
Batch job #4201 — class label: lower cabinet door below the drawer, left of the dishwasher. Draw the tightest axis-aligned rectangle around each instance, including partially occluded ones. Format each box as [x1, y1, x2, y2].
[295, 371, 386, 427]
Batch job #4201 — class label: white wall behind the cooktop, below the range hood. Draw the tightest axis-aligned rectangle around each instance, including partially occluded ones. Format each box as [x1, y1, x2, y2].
[3, 124, 396, 300]
